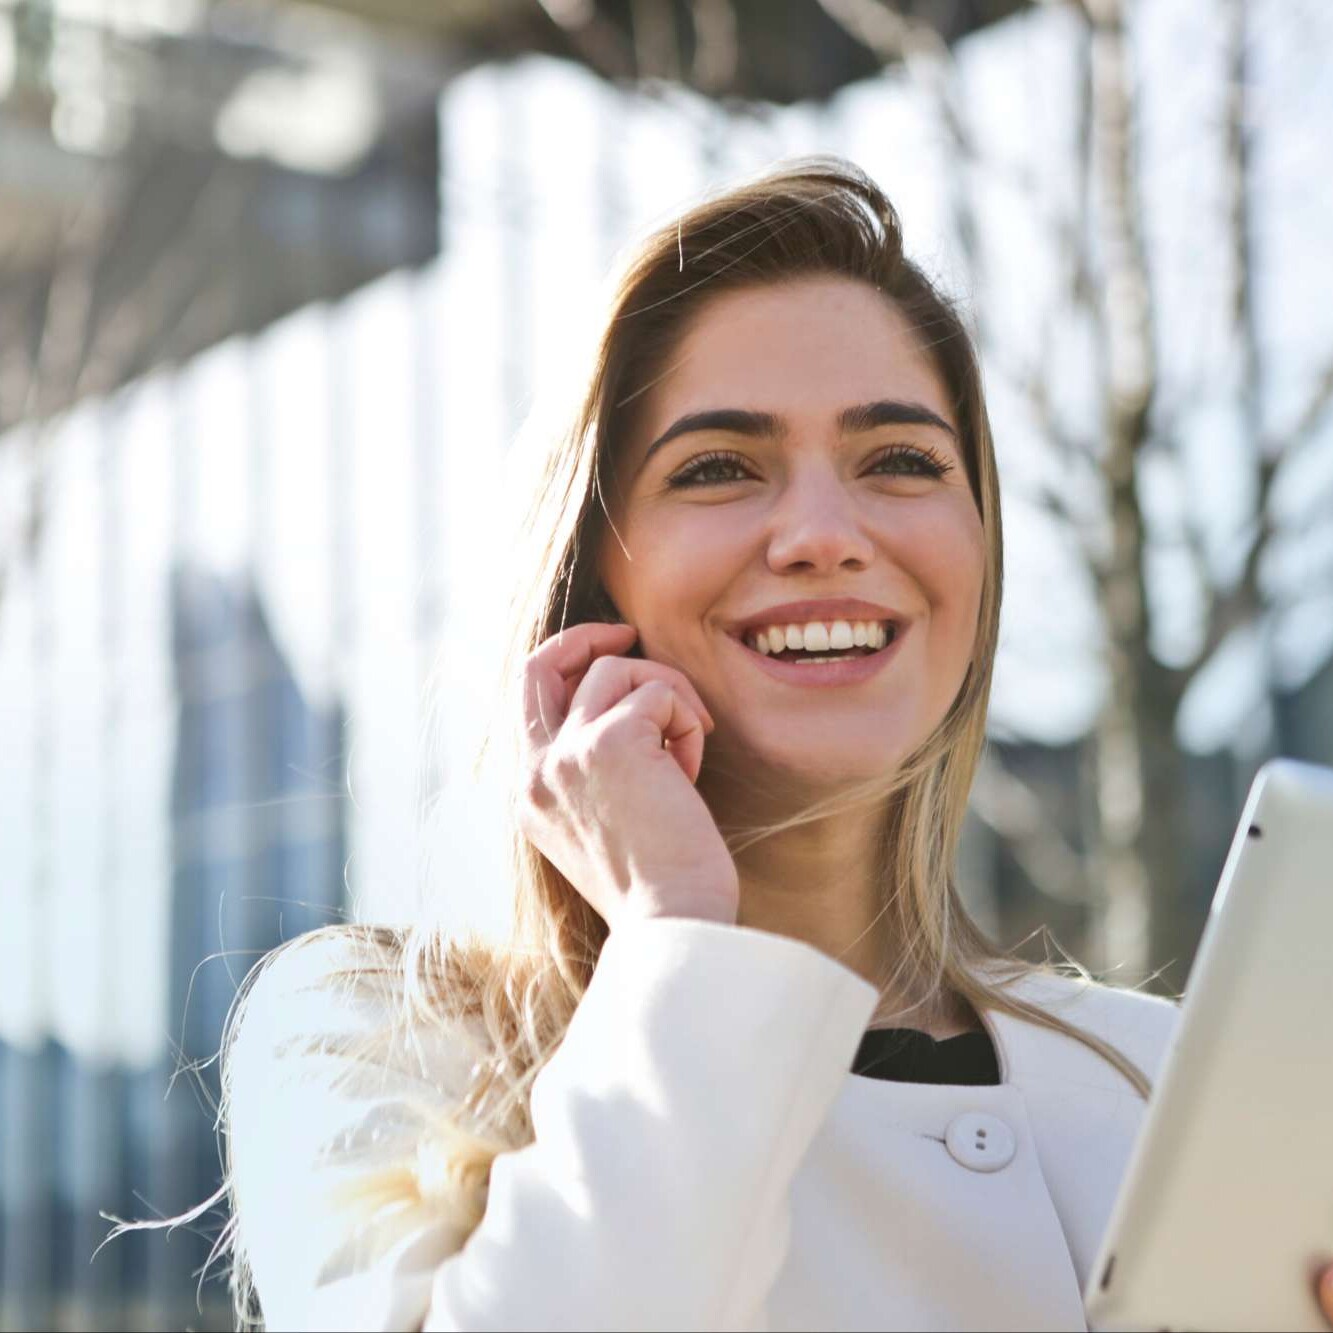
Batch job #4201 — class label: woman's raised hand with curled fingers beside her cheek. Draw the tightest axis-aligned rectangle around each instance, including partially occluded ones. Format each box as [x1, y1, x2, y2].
[520, 624, 740, 929]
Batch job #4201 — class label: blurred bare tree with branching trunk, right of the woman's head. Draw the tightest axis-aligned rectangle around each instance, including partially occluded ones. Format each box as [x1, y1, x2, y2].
[820, 0, 1333, 989]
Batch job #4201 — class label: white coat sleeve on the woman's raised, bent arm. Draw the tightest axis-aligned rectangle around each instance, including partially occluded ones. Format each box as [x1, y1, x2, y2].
[233, 918, 876, 1330]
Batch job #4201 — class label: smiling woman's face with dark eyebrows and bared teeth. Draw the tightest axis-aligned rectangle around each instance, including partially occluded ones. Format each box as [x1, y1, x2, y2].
[599, 276, 985, 784]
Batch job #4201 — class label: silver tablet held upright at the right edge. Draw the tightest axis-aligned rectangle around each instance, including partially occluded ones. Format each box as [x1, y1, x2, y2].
[1084, 760, 1333, 1333]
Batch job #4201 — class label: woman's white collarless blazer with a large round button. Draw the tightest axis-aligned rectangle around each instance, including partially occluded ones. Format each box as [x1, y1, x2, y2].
[229, 920, 1178, 1330]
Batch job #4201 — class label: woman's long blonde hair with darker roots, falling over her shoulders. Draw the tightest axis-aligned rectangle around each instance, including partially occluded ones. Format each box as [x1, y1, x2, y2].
[108, 159, 1149, 1326]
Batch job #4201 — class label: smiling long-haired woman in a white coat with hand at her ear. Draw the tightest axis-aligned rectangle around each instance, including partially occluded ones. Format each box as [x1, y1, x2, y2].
[202, 161, 1327, 1329]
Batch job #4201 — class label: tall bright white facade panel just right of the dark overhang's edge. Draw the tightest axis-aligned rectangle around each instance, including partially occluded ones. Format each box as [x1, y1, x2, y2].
[424, 68, 533, 933]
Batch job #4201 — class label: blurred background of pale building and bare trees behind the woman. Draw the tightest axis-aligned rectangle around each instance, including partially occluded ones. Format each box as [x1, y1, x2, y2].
[0, 0, 1333, 1329]
